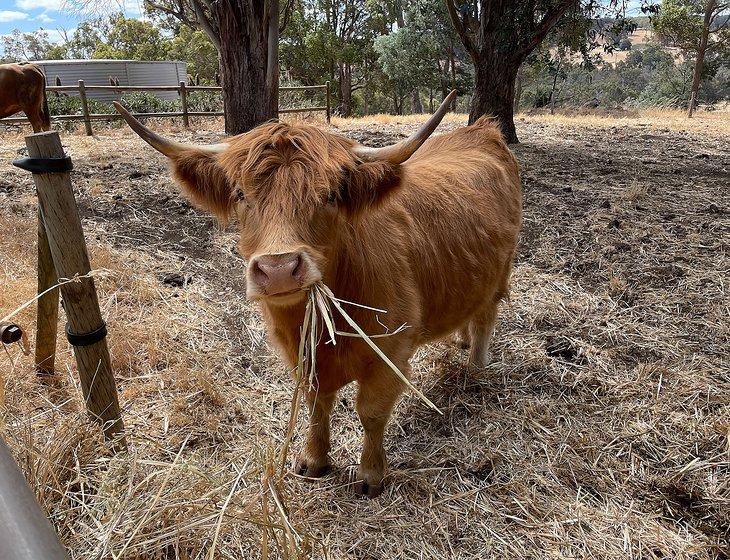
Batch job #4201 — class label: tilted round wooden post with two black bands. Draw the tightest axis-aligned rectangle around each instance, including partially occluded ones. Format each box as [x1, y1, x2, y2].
[15, 132, 126, 449]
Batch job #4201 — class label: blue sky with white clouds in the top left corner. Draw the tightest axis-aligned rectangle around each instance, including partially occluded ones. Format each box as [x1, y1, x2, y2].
[0, 0, 142, 42]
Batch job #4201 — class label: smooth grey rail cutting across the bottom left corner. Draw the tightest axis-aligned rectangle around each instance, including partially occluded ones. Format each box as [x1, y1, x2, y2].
[0, 439, 68, 560]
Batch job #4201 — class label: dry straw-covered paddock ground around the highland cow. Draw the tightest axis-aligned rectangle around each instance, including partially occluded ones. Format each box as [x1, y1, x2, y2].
[0, 110, 730, 559]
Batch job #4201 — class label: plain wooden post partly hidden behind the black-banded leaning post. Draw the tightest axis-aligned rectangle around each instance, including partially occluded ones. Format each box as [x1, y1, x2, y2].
[35, 207, 58, 374]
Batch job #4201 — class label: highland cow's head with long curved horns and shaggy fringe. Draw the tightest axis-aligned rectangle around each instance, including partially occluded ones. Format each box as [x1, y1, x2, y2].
[115, 92, 455, 305]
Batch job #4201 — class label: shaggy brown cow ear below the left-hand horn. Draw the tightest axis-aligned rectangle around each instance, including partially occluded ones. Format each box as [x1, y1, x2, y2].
[170, 149, 235, 221]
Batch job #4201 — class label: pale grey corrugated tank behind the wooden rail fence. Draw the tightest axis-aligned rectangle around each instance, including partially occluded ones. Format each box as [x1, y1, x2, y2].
[33, 59, 188, 103]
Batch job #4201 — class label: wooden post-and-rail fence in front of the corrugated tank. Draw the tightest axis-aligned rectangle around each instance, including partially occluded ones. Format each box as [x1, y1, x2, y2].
[0, 80, 332, 136]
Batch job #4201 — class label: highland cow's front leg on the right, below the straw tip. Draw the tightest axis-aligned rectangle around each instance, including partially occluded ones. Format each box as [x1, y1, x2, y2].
[356, 372, 408, 498]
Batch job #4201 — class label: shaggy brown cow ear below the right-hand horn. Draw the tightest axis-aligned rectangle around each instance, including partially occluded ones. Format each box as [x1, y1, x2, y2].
[340, 161, 401, 216]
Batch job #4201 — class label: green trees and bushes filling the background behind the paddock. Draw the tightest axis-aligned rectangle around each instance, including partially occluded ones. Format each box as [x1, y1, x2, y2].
[0, 0, 730, 115]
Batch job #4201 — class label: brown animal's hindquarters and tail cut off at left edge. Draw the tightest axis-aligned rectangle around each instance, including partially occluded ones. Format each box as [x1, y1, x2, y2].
[0, 64, 51, 132]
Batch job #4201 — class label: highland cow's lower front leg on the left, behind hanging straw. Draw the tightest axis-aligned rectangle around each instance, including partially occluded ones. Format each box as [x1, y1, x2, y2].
[294, 391, 337, 478]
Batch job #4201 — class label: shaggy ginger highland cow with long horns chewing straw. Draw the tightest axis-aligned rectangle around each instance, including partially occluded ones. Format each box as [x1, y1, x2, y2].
[117, 94, 522, 497]
